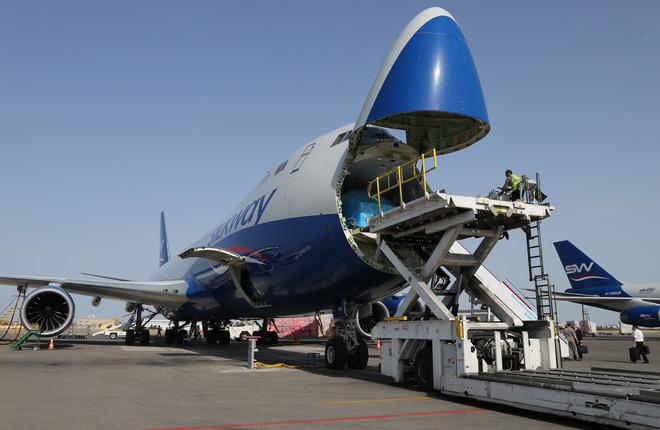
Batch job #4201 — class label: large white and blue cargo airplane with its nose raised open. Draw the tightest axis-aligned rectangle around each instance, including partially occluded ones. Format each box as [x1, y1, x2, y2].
[0, 8, 490, 368]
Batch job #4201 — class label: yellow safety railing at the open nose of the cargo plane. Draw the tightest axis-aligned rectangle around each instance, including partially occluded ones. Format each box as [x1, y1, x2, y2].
[367, 148, 438, 215]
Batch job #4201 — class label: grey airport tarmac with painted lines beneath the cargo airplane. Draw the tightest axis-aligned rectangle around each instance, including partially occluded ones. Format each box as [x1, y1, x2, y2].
[0, 337, 648, 430]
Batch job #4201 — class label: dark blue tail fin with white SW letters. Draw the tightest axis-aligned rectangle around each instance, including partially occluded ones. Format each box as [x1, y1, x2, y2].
[554, 240, 622, 288]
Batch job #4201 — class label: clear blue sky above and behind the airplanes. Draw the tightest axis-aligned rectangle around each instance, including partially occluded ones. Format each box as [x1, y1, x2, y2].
[0, 0, 660, 323]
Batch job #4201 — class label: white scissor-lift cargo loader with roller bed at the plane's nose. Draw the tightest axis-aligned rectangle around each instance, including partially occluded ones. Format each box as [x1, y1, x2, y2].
[369, 182, 660, 428]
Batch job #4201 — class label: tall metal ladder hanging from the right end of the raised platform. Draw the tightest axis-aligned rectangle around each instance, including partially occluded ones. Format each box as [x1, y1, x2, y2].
[524, 220, 557, 321]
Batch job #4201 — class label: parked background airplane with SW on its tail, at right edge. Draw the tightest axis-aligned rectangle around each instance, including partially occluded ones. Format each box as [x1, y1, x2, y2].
[554, 240, 660, 327]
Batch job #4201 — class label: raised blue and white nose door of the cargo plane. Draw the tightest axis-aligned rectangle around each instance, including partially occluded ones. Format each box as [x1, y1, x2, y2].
[355, 8, 490, 154]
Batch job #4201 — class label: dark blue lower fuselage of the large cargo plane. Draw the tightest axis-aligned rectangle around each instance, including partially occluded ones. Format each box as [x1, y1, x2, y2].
[175, 214, 403, 319]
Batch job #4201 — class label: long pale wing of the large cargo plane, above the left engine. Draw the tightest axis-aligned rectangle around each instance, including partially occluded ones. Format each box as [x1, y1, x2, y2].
[0, 275, 188, 307]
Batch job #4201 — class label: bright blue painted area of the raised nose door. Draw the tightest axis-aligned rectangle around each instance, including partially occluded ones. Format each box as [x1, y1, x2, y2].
[367, 16, 488, 123]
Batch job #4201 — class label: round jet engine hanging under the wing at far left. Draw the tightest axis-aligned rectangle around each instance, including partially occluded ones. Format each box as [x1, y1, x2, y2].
[21, 285, 76, 336]
